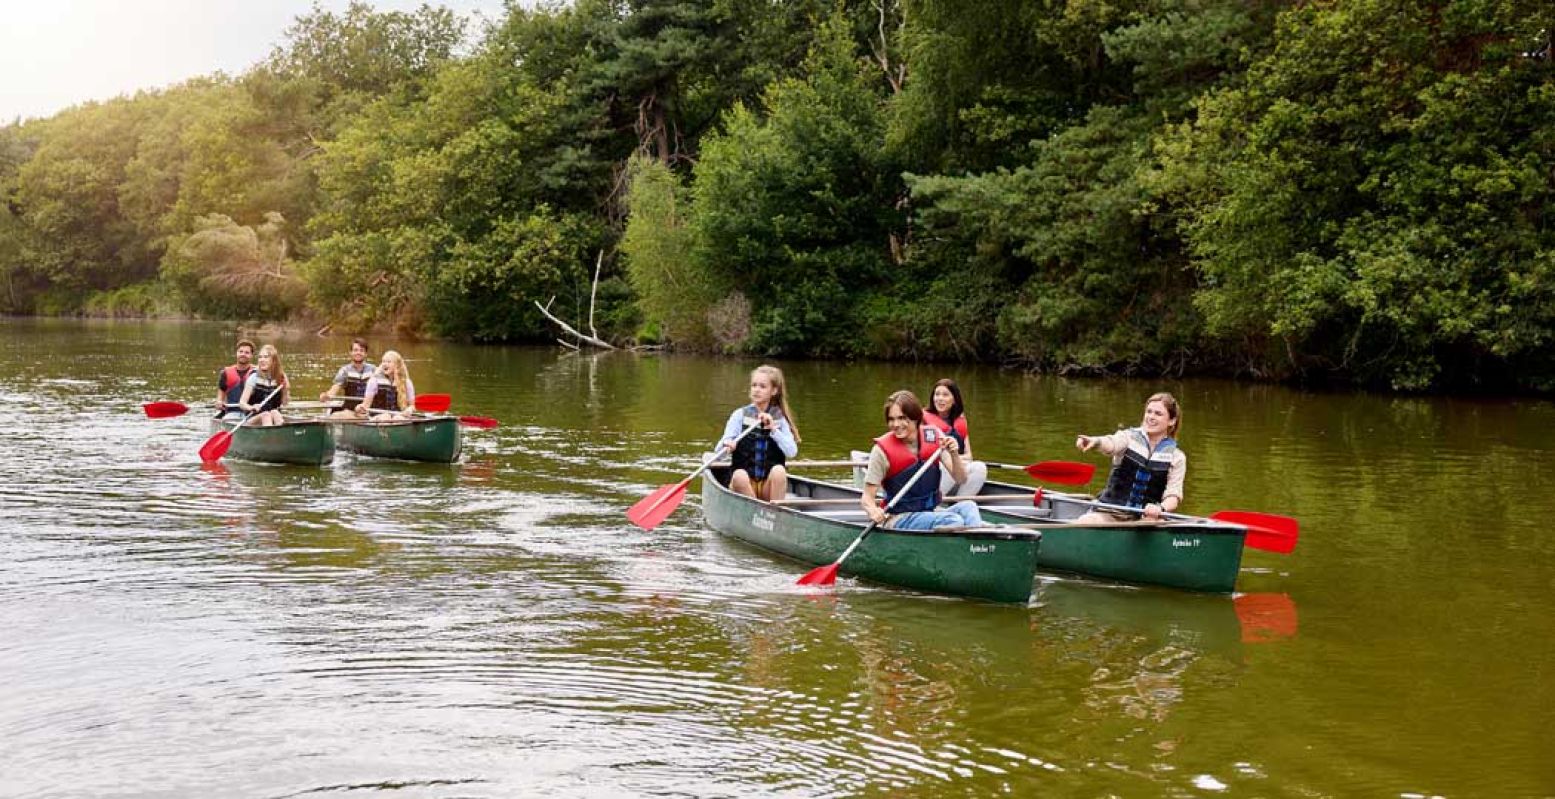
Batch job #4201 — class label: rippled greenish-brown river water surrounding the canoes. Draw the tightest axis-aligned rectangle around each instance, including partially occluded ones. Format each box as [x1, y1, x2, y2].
[0, 320, 1555, 797]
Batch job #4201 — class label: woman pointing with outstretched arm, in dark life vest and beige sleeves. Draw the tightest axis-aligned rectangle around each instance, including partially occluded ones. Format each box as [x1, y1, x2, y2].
[1075, 392, 1188, 524]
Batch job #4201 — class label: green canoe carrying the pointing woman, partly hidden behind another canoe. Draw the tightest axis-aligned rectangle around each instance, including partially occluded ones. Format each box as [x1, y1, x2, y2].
[978, 482, 1247, 594]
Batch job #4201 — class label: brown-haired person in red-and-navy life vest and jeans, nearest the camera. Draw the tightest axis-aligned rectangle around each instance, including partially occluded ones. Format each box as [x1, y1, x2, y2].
[860, 390, 983, 530]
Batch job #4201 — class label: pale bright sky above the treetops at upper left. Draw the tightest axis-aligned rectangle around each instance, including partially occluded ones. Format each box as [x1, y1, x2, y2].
[0, 0, 502, 124]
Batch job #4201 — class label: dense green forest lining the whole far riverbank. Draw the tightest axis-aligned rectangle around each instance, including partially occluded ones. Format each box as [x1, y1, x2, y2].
[0, 0, 1555, 392]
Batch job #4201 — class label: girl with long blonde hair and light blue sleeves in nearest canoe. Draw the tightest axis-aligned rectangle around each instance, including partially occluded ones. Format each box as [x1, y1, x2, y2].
[718, 365, 799, 502]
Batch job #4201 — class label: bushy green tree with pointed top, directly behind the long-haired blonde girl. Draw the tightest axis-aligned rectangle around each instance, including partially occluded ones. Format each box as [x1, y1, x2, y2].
[692, 20, 899, 354]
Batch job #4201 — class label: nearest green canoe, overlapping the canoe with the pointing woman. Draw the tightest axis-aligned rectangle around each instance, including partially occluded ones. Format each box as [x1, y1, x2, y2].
[701, 466, 1042, 602]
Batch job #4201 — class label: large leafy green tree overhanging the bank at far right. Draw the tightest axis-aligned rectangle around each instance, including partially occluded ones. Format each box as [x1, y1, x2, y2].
[1162, 0, 1555, 389]
